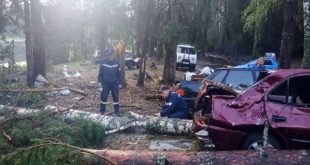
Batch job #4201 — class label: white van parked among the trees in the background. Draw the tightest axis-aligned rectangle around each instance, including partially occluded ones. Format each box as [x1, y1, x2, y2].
[176, 45, 197, 71]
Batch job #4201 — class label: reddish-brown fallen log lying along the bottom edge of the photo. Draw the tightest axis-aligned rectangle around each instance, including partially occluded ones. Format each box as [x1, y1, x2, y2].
[91, 149, 310, 165]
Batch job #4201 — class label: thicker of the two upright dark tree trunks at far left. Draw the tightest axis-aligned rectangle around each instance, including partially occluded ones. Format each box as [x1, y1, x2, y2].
[30, 0, 46, 77]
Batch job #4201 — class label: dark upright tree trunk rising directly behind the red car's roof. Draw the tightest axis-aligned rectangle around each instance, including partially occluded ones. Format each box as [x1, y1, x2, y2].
[279, 0, 298, 69]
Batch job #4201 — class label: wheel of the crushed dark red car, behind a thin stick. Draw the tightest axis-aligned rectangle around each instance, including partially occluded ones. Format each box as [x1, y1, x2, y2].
[240, 133, 281, 150]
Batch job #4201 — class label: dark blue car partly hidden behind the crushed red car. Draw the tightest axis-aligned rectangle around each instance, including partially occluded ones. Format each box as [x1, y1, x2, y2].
[176, 68, 260, 109]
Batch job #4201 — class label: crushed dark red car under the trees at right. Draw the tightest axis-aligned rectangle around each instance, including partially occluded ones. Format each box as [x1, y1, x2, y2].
[194, 69, 310, 149]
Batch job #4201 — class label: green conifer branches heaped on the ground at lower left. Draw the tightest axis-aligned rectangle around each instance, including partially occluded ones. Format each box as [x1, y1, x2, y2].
[0, 113, 104, 164]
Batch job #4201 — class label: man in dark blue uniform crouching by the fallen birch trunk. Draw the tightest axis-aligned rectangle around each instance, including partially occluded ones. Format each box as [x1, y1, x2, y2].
[156, 86, 189, 119]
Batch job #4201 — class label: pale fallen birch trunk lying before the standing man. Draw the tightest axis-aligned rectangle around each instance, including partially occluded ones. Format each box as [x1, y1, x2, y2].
[0, 105, 192, 134]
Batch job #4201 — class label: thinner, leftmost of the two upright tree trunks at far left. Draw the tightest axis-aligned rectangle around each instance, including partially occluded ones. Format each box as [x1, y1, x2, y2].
[24, 0, 36, 87]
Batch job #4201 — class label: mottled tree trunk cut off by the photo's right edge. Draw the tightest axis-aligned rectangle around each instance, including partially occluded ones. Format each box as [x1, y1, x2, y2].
[301, 0, 310, 69]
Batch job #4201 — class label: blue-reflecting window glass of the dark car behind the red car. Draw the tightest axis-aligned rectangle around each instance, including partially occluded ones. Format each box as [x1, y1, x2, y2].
[225, 71, 254, 86]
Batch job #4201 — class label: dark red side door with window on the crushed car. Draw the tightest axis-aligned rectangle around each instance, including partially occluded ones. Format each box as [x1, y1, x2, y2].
[265, 75, 310, 149]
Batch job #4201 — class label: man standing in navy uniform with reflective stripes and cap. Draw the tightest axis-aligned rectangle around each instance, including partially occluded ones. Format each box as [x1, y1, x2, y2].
[98, 49, 123, 116]
